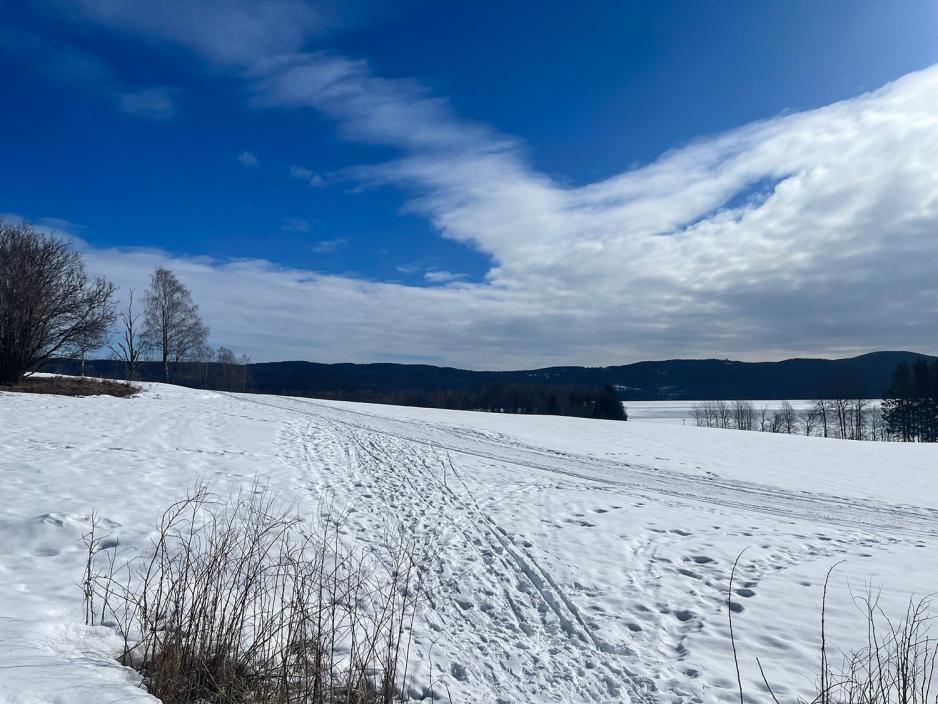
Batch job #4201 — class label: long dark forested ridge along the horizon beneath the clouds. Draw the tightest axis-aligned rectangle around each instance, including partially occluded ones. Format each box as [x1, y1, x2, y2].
[47, 352, 933, 401]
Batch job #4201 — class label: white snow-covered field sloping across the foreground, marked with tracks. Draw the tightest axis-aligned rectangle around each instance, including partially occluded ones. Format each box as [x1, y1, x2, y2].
[0, 384, 938, 704]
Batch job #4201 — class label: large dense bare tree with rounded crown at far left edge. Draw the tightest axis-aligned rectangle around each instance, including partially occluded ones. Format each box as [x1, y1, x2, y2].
[0, 222, 114, 384]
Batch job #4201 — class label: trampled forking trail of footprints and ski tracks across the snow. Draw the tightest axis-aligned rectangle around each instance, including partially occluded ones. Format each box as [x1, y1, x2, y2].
[230, 396, 938, 703]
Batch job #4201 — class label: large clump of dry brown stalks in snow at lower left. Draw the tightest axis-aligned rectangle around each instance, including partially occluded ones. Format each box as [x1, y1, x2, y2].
[83, 485, 426, 704]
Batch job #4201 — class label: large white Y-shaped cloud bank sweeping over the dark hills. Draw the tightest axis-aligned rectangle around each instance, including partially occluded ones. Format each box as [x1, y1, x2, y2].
[14, 5, 938, 368]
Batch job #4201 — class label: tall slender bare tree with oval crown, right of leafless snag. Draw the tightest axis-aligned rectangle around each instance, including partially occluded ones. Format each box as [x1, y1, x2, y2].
[144, 267, 208, 382]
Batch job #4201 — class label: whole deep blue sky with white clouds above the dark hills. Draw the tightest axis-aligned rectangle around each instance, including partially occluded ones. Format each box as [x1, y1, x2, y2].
[0, 0, 938, 368]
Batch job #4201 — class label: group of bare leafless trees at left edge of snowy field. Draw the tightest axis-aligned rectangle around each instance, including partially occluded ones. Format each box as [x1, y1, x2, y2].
[0, 222, 248, 389]
